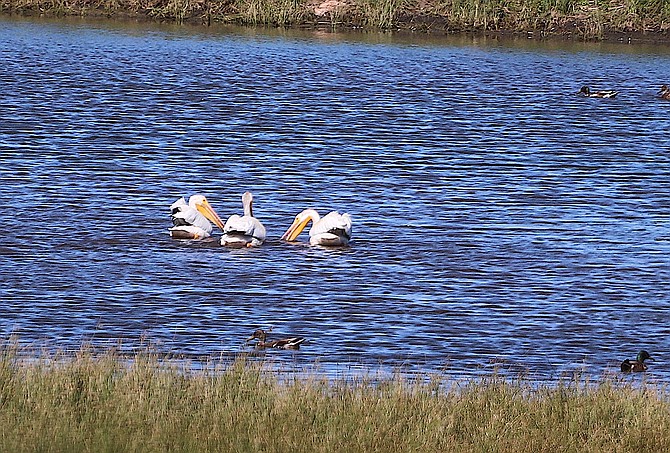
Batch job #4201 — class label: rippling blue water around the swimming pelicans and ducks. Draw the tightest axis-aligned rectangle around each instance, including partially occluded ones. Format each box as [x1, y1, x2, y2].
[0, 18, 670, 382]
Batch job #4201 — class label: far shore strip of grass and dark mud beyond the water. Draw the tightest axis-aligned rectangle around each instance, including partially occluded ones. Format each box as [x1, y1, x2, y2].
[0, 0, 670, 41]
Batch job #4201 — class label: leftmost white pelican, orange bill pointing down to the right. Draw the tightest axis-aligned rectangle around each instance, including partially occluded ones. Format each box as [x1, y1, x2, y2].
[169, 195, 223, 239]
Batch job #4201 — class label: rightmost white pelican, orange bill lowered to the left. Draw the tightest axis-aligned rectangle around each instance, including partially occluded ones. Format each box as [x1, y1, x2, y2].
[281, 209, 351, 245]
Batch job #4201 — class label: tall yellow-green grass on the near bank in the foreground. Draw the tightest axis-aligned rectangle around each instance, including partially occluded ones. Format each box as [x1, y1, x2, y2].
[0, 348, 670, 452]
